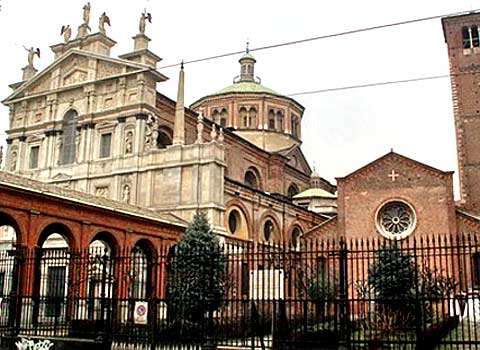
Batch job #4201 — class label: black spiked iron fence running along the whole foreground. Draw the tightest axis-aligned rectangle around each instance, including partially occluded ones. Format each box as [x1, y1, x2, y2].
[0, 235, 480, 350]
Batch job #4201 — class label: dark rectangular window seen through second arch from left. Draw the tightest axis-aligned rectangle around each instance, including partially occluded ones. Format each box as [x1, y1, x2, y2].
[45, 266, 67, 317]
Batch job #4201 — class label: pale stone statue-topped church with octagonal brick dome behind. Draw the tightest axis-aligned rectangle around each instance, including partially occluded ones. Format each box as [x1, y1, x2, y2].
[3, 8, 335, 246]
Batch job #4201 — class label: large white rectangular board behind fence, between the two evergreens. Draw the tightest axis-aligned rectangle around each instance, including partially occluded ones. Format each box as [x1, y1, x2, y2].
[250, 269, 285, 300]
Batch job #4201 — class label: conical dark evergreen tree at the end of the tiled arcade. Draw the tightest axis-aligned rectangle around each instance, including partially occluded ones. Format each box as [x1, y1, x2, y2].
[168, 213, 225, 329]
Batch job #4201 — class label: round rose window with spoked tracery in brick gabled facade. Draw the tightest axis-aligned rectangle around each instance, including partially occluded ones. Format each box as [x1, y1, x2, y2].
[377, 201, 416, 239]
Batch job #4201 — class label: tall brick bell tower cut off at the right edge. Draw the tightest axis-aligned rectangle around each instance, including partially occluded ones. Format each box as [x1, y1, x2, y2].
[442, 12, 480, 214]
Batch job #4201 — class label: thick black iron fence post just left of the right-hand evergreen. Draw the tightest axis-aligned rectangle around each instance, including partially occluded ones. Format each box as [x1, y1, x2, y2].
[338, 239, 350, 350]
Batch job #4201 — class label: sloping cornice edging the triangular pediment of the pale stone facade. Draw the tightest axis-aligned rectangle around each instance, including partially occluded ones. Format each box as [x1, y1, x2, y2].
[2, 49, 168, 104]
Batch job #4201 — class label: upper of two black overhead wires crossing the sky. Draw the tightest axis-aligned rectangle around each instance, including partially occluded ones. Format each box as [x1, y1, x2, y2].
[157, 9, 480, 69]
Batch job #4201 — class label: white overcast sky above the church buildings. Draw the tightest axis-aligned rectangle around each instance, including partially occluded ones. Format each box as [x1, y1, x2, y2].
[0, 0, 474, 197]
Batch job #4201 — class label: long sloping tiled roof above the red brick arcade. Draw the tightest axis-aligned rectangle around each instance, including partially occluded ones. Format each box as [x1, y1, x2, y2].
[0, 171, 188, 227]
